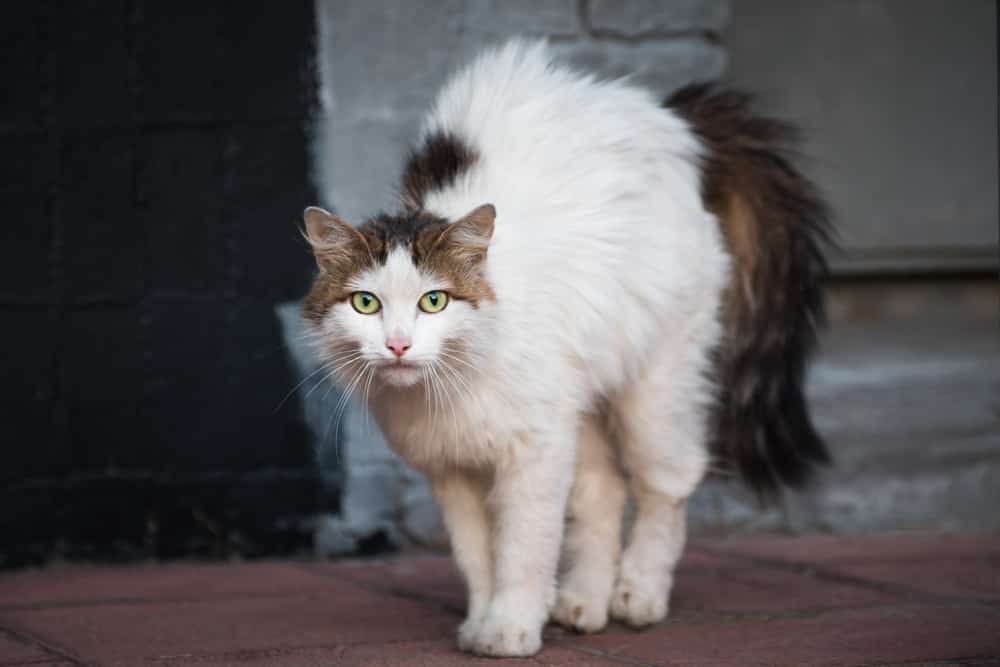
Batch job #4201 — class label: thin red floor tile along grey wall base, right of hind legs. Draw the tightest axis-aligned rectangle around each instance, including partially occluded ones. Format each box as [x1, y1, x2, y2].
[692, 533, 1000, 564]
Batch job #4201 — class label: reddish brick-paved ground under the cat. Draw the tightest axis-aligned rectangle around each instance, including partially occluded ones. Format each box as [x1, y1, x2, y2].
[0, 534, 1000, 666]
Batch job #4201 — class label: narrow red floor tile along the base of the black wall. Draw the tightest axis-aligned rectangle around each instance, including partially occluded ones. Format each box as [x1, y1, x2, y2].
[0, 562, 340, 609]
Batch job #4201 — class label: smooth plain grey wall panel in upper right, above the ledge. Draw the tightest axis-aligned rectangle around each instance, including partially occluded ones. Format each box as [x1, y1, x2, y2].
[725, 0, 998, 272]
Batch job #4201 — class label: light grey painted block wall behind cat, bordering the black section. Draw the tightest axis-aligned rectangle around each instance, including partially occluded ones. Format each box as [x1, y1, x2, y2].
[304, 0, 731, 553]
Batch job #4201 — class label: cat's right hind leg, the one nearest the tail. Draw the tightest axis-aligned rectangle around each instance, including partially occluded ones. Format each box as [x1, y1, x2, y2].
[610, 326, 713, 627]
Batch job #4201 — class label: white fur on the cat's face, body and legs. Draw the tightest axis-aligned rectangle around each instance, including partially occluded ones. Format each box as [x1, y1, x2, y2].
[312, 41, 728, 655]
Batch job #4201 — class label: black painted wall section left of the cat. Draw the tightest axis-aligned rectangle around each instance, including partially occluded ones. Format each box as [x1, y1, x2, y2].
[0, 0, 325, 566]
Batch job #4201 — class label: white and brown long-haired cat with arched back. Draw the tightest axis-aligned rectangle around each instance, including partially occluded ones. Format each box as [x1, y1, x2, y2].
[303, 40, 830, 656]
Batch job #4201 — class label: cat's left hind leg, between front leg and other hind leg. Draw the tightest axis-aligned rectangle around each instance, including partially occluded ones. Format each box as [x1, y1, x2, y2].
[552, 417, 625, 632]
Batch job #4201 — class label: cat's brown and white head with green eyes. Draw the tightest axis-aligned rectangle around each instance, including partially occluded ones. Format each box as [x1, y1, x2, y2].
[303, 204, 496, 387]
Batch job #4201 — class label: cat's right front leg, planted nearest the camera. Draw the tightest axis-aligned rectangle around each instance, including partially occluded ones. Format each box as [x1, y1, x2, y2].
[471, 428, 574, 656]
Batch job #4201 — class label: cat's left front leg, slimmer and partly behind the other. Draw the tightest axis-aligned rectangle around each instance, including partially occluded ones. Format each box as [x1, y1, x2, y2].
[430, 472, 493, 651]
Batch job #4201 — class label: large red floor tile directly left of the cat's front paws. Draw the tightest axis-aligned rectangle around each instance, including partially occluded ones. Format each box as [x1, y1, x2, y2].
[0, 578, 458, 664]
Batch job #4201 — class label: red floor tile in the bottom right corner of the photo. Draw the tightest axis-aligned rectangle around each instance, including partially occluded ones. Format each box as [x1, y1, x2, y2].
[576, 606, 1000, 667]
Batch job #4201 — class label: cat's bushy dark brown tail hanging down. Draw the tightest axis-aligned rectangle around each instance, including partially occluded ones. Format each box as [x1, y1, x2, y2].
[666, 85, 831, 497]
